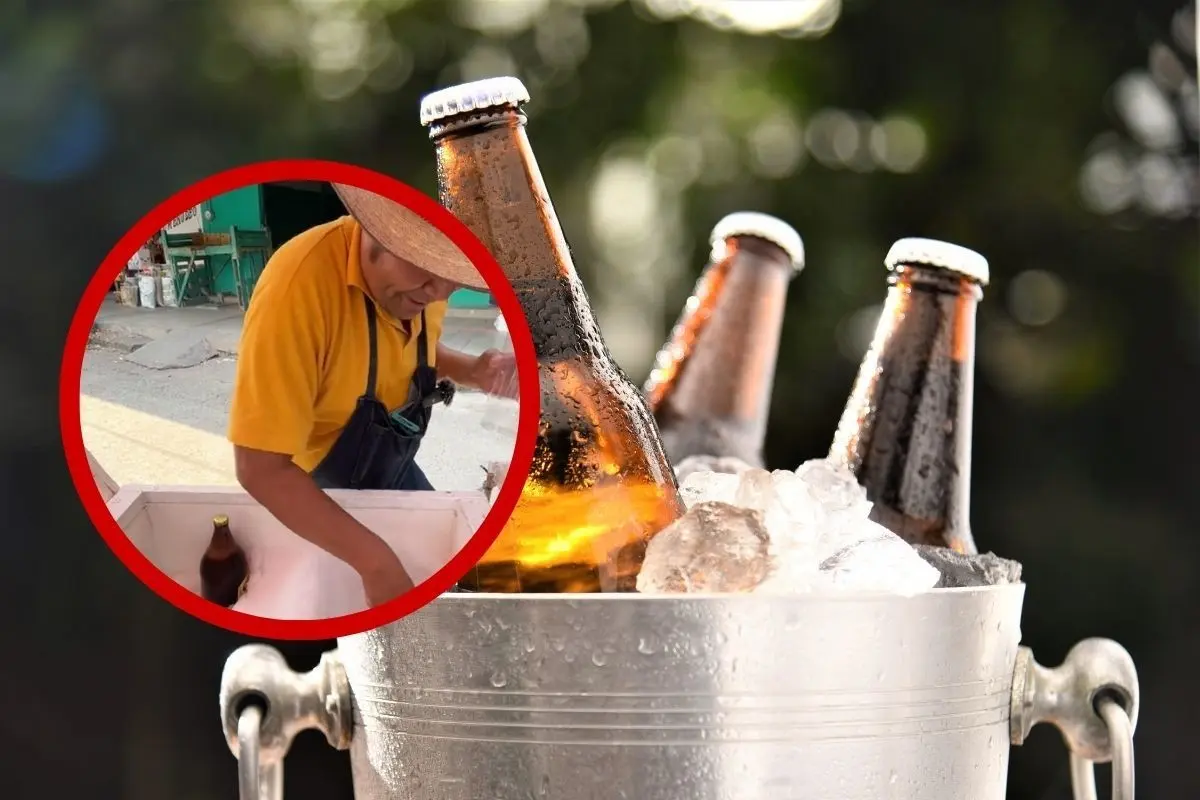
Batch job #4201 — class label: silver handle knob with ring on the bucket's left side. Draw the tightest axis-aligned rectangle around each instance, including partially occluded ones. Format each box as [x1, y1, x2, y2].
[221, 644, 353, 800]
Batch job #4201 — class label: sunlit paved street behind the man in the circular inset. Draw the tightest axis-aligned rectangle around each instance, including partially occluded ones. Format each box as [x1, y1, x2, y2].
[80, 299, 516, 491]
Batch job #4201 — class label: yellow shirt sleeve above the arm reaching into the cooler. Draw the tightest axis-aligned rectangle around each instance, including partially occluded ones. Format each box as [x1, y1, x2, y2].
[228, 261, 325, 456]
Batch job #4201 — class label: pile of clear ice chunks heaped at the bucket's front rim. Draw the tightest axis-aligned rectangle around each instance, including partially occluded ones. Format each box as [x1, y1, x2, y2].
[637, 458, 942, 595]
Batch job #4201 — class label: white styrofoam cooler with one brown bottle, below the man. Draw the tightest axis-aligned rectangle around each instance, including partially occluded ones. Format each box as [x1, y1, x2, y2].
[108, 486, 488, 620]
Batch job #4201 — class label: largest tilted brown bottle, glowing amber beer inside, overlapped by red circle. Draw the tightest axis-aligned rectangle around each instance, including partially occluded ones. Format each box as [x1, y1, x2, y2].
[421, 78, 683, 593]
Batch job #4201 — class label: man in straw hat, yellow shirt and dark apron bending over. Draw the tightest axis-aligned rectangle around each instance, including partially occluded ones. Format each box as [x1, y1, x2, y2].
[229, 185, 516, 606]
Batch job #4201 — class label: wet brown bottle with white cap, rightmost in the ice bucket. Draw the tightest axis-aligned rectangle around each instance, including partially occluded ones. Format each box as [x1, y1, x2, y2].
[829, 239, 988, 554]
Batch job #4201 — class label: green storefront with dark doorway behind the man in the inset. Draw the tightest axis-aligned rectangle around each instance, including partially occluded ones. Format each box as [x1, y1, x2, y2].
[161, 181, 493, 308]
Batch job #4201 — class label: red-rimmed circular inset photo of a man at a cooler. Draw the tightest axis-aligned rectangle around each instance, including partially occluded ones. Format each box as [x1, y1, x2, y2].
[60, 161, 540, 639]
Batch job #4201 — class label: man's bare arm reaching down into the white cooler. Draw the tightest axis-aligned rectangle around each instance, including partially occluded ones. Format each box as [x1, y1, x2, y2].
[234, 445, 412, 594]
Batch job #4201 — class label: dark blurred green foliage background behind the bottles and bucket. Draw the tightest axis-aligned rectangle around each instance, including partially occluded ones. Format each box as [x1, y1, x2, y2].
[0, 0, 1200, 800]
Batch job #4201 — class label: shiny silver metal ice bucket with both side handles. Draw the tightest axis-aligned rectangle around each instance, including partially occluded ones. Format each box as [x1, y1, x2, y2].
[221, 584, 1139, 800]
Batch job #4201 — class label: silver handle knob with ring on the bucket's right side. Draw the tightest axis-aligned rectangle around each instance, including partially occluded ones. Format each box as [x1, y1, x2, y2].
[1009, 639, 1139, 800]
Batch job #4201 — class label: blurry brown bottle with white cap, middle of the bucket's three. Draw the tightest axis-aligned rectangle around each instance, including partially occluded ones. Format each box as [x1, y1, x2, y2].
[644, 211, 804, 468]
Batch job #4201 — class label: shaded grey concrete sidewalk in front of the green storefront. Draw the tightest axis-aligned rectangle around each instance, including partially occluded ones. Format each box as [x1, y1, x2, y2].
[90, 295, 499, 369]
